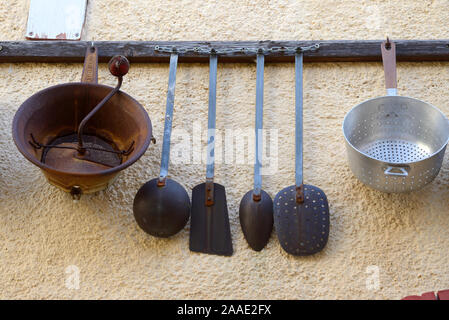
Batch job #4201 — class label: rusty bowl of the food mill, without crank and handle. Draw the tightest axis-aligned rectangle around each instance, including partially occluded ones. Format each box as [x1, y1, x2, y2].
[13, 83, 152, 193]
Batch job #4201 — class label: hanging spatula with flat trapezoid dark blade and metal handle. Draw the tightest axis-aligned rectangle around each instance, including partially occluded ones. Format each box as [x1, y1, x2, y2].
[190, 52, 233, 256]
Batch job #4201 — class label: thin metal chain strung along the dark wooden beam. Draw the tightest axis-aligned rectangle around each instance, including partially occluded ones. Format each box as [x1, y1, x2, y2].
[154, 43, 320, 55]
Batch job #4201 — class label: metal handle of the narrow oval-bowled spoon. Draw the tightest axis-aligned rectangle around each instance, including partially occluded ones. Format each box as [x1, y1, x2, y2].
[253, 53, 265, 201]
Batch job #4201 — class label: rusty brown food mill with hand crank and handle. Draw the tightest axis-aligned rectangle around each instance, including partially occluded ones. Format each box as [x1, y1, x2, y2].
[12, 46, 153, 197]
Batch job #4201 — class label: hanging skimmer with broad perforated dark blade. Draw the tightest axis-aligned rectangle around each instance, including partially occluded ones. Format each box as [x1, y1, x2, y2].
[274, 48, 329, 256]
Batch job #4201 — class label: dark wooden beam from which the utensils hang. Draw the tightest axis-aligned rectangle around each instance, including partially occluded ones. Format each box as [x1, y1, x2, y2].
[0, 40, 449, 63]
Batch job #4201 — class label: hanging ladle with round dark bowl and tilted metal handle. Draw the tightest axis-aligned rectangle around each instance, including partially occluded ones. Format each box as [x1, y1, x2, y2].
[133, 52, 190, 237]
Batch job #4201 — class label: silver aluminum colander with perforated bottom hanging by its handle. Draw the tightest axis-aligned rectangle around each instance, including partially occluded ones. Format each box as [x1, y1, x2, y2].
[343, 40, 449, 193]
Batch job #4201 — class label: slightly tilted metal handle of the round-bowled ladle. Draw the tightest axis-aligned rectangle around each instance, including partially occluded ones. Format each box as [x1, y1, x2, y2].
[158, 53, 178, 186]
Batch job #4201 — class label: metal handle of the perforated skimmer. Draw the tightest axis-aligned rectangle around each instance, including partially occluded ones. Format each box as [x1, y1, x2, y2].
[295, 51, 304, 203]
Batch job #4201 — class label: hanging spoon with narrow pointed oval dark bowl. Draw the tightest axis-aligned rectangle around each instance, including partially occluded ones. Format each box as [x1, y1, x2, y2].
[239, 52, 273, 251]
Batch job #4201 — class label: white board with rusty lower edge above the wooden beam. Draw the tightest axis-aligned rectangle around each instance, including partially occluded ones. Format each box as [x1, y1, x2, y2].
[25, 0, 87, 40]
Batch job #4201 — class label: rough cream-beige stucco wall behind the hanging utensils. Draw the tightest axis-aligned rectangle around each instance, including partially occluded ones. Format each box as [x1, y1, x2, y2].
[0, 0, 449, 299]
